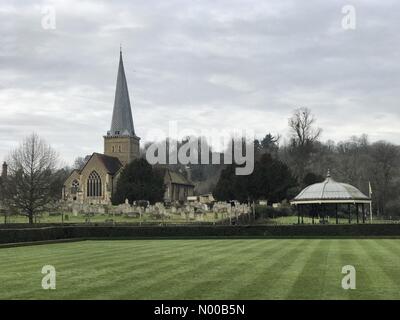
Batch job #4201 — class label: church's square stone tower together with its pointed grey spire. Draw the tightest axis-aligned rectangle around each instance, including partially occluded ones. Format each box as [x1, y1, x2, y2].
[104, 51, 140, 165]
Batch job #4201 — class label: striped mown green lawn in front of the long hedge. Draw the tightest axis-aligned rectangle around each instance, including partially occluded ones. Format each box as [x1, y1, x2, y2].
[0, 239, 400, 299]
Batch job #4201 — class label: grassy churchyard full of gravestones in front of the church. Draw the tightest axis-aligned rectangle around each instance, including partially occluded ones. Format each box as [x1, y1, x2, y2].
[0, 200, 252, 225]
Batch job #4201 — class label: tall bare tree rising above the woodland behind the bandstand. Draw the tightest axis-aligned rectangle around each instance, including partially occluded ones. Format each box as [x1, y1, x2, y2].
[289, 108, 322, 182]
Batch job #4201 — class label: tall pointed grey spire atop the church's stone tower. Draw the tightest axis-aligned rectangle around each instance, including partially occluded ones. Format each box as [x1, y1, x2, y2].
[107, 51, 135, 136]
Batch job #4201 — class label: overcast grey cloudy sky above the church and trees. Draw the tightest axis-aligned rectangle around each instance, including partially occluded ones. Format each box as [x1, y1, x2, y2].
[0, 0, 400, 164]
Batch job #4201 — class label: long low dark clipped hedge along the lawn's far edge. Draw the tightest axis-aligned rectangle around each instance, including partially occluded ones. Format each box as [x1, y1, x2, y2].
[0, 224, 400, 244]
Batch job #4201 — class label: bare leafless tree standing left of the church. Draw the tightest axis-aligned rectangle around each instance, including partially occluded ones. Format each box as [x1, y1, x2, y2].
[6, 134, 58, 224]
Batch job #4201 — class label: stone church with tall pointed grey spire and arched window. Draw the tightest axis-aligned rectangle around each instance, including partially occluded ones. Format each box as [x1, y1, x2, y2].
[62, 52, 194, 204]
